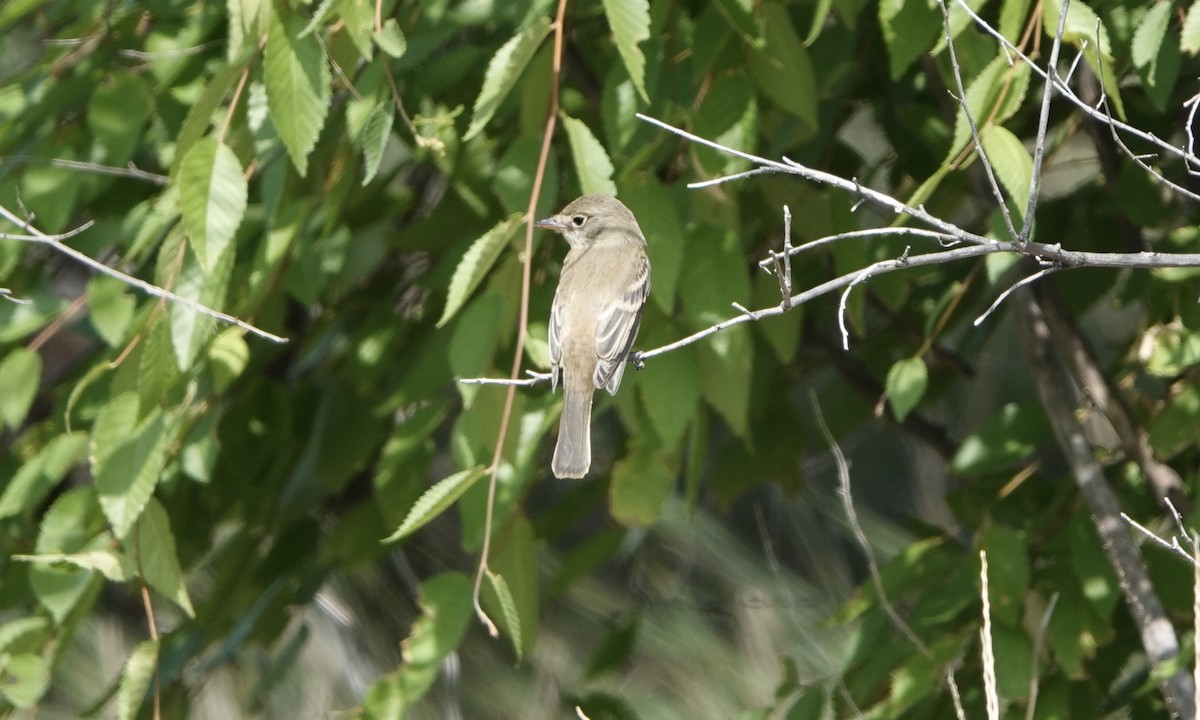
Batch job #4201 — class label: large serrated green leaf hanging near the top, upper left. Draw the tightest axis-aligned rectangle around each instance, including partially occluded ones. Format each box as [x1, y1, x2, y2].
[263, 17, 331, 176]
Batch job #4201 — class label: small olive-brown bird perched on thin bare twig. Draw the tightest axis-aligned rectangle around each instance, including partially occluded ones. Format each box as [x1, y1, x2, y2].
[535, 194, 650, 478]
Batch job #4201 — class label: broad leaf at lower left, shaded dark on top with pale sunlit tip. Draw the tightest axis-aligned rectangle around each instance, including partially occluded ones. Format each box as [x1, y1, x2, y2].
[91, 392, 170, 539]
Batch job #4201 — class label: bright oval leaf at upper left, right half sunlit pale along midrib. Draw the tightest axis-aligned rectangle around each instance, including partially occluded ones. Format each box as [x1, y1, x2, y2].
[175, 138, 247, 270]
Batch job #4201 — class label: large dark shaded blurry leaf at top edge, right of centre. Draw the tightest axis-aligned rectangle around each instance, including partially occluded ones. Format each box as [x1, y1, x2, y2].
[749, 0, 816, 133]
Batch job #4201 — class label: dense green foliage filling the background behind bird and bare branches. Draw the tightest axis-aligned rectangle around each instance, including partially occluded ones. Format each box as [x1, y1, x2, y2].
[0, 0, 1200, 720]
